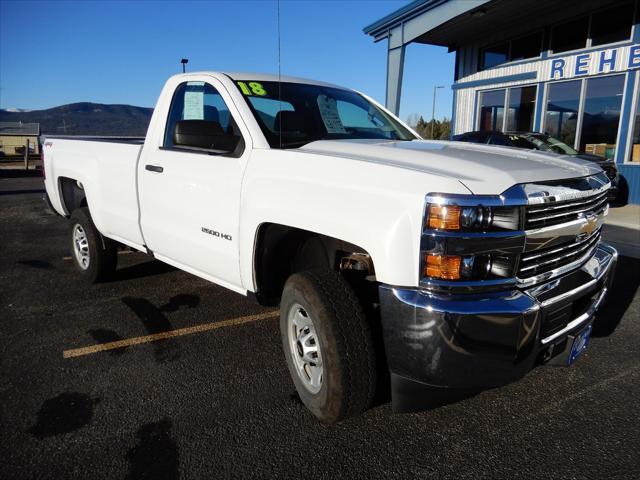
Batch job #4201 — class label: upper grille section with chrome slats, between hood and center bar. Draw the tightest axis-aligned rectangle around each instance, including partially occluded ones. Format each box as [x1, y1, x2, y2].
[525, 191, 607, 230]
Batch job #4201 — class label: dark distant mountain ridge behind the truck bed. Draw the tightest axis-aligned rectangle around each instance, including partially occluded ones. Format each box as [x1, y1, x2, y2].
[0, 102, 153, 137]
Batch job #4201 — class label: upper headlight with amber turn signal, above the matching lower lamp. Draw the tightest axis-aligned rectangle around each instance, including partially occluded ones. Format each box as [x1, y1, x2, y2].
[425, 203, 520, 232]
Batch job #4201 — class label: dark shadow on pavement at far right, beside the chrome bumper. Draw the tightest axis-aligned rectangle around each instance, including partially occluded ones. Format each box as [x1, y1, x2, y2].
[592, 256, 640, 337]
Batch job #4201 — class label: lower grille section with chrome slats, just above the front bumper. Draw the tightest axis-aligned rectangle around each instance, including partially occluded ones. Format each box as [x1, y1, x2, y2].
[518, 229, 601, 279]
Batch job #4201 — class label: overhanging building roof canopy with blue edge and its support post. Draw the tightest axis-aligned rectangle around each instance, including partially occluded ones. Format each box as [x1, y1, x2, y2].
[363, 0, 626, 114]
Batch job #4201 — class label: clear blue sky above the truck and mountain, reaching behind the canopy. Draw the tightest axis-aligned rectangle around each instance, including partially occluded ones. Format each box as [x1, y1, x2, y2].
[0, 0, 454, 123]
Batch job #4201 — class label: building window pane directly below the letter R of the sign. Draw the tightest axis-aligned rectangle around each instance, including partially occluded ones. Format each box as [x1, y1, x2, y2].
[544, 80, 582, 145]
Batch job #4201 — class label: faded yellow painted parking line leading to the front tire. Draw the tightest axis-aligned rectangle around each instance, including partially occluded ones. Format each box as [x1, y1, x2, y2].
[62, 311, 278, 358]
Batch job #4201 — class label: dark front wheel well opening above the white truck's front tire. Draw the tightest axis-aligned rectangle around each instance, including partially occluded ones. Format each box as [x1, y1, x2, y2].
[253, 223, 375, 305]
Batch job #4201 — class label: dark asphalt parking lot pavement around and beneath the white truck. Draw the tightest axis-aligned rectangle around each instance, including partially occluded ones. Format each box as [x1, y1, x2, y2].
[0, 170, 640, 479]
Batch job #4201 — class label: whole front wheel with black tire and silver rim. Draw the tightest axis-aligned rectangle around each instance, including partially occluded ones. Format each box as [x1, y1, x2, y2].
[280, 270, 376, 423]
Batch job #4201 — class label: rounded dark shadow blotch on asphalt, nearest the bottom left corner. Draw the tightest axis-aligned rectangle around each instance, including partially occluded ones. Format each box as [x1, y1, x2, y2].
[27, 392, 100, 439]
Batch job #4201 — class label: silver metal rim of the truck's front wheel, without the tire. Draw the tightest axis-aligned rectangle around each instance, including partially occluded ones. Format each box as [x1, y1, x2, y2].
[287, 303, 323, 394]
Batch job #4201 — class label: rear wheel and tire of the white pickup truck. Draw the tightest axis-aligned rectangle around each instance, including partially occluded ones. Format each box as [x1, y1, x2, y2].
[70, 207, 118, 283]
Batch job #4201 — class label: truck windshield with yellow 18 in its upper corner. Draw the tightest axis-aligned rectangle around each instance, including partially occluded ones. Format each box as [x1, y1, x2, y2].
[236, 80, 417, 148]
